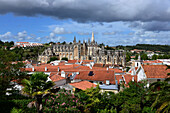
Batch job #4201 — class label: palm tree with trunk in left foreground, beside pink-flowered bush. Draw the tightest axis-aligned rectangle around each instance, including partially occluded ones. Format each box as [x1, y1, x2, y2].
[22, 72, 53, 113]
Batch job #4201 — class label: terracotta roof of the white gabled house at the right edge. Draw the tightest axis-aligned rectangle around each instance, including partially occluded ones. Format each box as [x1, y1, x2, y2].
[143, 65, 170, 78]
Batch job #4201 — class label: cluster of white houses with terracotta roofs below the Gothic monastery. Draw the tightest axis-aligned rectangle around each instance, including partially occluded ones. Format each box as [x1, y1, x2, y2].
[7, 57, 166, 93]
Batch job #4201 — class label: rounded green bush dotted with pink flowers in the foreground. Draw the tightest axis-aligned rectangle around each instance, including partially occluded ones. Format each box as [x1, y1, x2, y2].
[43, 90, 82, 113]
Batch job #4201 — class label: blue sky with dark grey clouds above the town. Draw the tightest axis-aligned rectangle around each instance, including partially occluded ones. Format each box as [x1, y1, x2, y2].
[0, 0, 170, 46]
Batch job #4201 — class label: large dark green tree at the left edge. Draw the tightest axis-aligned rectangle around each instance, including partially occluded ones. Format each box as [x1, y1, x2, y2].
[0, 50, 26, 97]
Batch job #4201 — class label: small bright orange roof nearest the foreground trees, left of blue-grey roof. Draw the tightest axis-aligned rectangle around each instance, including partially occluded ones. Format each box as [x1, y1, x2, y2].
[69, 81, 96, 90]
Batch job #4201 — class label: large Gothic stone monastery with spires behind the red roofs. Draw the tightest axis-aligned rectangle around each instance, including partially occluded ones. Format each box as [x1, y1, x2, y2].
[38, 33, 126, 66]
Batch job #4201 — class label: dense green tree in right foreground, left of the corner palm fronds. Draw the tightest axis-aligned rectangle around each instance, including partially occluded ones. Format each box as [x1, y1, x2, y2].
[115, 82, 147, 113]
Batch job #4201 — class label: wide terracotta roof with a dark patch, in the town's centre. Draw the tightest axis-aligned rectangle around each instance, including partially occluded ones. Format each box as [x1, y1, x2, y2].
[75, 70, 115, 84]
